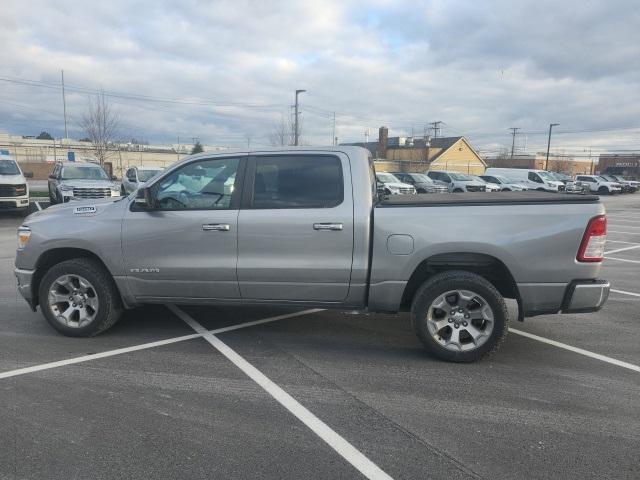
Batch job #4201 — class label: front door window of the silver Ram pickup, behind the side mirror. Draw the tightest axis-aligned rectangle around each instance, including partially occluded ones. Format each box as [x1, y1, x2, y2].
[156, 158, 240, 210]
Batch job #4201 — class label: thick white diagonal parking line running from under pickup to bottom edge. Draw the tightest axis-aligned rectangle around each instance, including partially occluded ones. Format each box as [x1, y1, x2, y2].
[168, 305, 391, 479]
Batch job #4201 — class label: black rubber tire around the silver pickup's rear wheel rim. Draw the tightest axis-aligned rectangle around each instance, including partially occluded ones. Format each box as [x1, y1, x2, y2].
[411, 270, 509, 362]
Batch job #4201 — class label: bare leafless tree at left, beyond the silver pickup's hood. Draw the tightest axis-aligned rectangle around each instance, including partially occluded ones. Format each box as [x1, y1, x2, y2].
[80, 90, 120, 165]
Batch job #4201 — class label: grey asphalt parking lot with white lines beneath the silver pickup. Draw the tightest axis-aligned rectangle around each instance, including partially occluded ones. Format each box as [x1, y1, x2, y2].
[0, 193, 640, 479]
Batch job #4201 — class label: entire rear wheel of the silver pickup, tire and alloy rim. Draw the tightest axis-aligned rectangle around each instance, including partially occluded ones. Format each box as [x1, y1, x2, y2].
[411, 271, 509, 362]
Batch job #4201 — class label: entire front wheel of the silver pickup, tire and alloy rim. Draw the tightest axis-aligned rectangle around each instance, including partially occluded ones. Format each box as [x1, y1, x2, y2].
[38, 258, 122, 337]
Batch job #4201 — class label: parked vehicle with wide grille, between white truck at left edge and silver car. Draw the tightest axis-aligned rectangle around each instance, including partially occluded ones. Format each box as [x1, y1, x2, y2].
[49, 162, 120, 205]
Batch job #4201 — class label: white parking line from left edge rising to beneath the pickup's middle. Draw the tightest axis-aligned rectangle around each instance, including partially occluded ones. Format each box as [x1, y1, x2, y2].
[0, 309, 322, 379]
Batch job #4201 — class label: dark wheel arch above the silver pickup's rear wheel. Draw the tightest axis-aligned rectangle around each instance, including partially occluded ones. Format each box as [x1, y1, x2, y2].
[400, 252, 524, 320]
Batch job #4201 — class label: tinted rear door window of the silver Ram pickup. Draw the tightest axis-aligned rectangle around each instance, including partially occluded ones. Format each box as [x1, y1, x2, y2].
[252, 155, 344, 208]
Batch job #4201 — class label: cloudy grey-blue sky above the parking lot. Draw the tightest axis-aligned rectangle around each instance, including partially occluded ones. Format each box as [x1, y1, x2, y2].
[0, 0, 640, 155]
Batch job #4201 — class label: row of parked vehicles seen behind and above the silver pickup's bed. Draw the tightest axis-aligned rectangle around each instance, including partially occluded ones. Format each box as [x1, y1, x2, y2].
[376, 168, 640, 195]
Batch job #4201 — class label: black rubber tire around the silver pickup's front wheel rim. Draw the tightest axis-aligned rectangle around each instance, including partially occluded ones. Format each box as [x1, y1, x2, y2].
[38, 258, 122, 337]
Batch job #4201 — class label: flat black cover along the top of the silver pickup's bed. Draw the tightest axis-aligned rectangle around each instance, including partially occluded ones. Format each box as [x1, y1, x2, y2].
[377, 191, 600, 208]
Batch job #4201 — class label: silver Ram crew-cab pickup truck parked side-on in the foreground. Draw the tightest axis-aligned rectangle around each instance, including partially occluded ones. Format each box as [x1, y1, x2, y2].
[15, 147, 609, 362]
